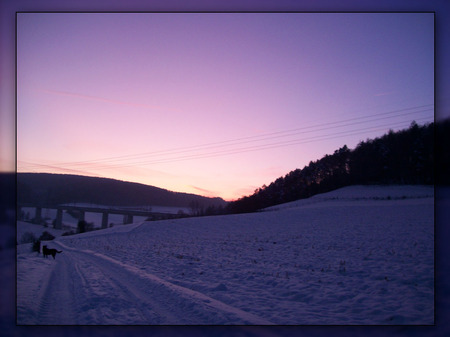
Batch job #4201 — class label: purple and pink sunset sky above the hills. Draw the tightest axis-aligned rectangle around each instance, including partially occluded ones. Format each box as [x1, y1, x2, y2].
[17, 13, 435, 200]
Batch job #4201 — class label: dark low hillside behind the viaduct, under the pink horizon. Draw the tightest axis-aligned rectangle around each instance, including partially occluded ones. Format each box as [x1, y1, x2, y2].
[17, 173, 227, 209]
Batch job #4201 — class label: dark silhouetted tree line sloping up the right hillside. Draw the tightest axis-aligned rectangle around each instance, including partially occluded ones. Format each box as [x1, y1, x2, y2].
[227, 121, 438, 213]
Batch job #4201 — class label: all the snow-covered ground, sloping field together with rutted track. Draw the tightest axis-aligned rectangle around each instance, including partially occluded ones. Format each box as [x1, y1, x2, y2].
[17, 186, 434, 325]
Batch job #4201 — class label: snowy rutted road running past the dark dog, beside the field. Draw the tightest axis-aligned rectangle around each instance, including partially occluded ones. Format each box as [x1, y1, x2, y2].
[18, 242, 271, 325]
